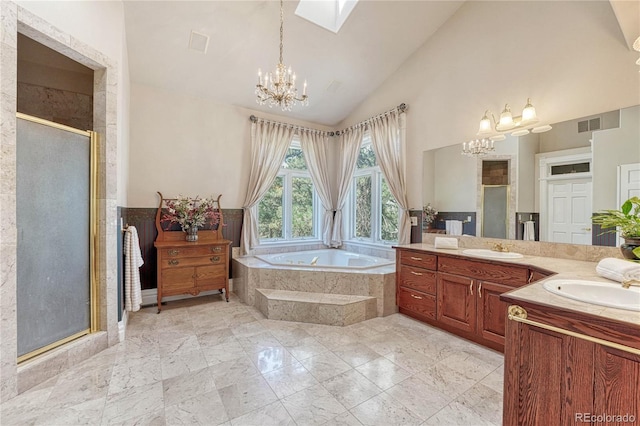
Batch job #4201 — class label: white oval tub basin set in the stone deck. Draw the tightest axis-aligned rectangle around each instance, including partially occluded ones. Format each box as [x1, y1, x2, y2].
[256, 249, 395, 269]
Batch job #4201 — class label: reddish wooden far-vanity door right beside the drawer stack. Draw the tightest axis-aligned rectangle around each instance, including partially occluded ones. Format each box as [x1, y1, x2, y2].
[437, 273, 476, 332]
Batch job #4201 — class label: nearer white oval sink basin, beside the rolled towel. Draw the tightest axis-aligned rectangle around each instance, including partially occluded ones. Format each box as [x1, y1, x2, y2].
[542, 280, 640, 311]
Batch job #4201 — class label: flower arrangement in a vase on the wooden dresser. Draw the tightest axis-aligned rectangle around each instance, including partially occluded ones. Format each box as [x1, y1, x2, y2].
[160, 195, 220, 231]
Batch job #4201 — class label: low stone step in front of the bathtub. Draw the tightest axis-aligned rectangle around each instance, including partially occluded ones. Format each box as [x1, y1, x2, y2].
[255, 288, 377, 326]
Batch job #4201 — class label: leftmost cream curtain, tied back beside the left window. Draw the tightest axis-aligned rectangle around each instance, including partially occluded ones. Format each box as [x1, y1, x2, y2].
[240, 120, 294, 255]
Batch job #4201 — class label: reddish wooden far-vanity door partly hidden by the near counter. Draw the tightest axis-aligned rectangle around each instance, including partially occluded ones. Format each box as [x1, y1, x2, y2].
[476, 281, 513, 345]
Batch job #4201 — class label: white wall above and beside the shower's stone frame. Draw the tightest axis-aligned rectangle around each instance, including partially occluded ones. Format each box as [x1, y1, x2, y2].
[16, 0, 129, 206]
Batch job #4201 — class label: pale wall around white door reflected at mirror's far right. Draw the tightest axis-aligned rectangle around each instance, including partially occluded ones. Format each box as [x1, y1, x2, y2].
[593, 106, 640, 212]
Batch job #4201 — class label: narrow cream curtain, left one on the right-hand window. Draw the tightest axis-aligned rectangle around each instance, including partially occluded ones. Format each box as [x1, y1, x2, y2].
[331, 126, 363, 247]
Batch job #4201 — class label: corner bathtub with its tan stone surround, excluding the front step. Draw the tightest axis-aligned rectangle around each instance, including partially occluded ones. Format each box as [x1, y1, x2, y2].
[232, 249, 397, 316]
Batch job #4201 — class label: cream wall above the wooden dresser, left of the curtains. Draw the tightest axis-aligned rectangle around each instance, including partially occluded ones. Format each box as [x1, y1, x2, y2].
[128, 83, 329, 209]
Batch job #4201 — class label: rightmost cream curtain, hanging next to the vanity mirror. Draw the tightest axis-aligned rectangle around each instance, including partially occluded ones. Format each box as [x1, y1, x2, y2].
[368, 111, 411, 244]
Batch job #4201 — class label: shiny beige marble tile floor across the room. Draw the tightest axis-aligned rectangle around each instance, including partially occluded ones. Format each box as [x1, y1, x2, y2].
[0, 296, 503, 426]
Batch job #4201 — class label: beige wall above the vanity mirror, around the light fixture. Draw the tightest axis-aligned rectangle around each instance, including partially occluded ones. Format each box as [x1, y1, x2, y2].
[339, 1, 640, 208]
